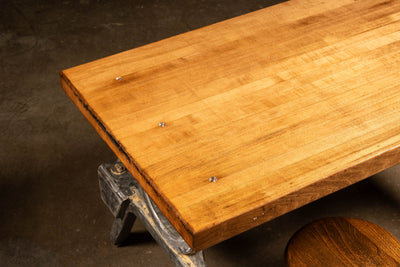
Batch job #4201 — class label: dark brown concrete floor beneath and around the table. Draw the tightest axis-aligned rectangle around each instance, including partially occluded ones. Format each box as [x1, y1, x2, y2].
[0, 0, 400, 267]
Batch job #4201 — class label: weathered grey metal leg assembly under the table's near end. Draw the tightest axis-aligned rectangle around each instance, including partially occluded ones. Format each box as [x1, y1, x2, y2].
[98, 161, 206, 267]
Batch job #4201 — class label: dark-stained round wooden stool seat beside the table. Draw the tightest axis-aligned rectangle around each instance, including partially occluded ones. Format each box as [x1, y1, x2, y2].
[285, 217, 400, 266]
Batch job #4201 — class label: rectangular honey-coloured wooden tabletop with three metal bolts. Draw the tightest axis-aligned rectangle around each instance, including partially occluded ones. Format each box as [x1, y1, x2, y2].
[61, 0, 400, 250]
